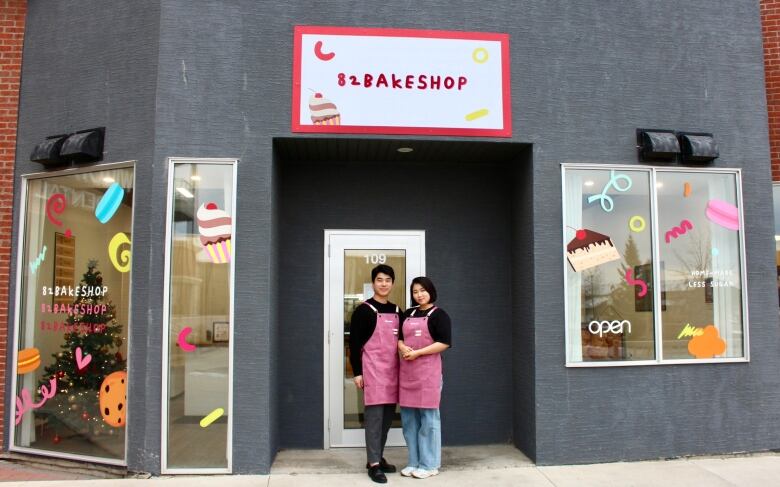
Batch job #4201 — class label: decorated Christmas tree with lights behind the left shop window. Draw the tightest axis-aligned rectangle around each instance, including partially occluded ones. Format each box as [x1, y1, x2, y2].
[39, 260, 126, 442]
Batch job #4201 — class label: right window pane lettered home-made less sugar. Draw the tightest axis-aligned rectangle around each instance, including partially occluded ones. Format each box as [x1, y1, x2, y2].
[656, 171, 743, 359]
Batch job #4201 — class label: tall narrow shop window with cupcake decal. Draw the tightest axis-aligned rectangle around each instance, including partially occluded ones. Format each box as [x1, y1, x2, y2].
[163, 160, 236, 473]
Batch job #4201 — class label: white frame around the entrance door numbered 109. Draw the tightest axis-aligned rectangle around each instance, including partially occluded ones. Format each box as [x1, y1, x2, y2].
[322, 229, 425, 450]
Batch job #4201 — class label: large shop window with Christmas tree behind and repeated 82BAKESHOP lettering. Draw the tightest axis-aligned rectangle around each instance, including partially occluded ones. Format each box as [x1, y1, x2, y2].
[11, 164, 134, 464]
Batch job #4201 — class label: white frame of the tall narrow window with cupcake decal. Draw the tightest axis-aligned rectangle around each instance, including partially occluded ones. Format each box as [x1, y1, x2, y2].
[160, 157, 240, 475]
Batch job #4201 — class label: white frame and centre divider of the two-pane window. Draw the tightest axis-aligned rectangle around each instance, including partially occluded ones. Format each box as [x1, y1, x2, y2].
[561, 163, 750, 368]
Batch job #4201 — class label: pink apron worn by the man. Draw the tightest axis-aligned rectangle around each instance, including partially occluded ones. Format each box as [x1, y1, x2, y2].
[362, 302, 398, 406]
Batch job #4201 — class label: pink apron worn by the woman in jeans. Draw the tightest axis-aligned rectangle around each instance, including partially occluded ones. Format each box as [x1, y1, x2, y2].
[398, 306, 442, 409]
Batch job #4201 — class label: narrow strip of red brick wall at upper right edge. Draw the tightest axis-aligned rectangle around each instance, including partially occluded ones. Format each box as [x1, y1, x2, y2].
[760, 0, 780, 181]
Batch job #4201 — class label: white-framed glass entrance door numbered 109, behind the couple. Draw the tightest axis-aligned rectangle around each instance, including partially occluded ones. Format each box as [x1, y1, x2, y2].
[325, 230, 425, 448]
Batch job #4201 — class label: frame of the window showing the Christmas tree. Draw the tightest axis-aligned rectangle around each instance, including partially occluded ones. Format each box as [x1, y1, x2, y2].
[6, 160, 138, 467]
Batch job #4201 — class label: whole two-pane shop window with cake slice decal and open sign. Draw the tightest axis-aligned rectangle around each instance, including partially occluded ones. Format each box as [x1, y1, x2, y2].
[563, 165, 747, 365]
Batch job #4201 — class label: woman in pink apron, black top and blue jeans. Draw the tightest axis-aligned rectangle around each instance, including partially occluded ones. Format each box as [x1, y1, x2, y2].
[398, 277, 452, 479]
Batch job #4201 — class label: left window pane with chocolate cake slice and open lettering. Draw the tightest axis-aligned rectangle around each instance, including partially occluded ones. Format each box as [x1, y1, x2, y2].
[565, 170, 655, 362]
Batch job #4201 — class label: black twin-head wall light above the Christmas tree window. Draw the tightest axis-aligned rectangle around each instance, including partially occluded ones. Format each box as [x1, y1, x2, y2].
[30, 127, 106, 167]
